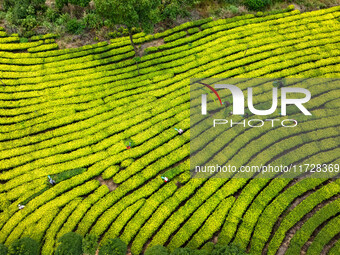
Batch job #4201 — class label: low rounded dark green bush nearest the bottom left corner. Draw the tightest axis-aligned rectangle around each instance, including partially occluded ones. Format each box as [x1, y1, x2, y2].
[7, 237, 39, 255]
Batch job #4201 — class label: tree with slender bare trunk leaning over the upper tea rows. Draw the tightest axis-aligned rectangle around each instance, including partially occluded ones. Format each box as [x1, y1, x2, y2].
[94, 0, 161, 69]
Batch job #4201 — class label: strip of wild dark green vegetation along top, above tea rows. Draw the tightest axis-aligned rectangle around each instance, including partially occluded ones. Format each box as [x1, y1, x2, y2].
[0, 0, 336, 39]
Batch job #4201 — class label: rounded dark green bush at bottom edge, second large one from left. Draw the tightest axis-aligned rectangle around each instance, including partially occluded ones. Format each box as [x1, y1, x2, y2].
[55, 232, 83, 255]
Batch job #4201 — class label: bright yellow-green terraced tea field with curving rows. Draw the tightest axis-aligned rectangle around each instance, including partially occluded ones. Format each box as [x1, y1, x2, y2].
[0, 4, 340, 255]
